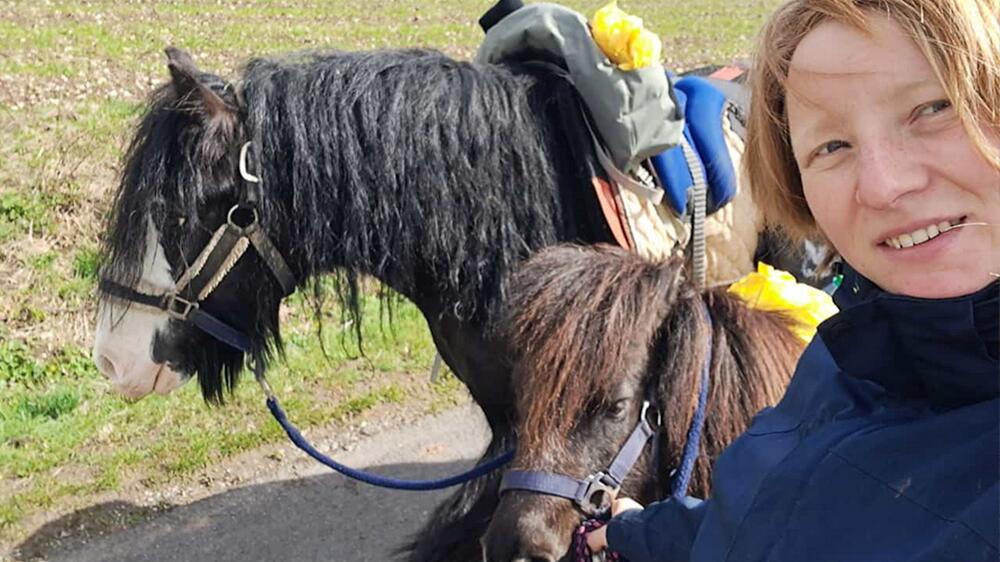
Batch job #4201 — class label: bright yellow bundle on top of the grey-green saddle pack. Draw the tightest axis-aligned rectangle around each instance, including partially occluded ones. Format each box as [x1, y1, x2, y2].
[590, 0, 662, 70]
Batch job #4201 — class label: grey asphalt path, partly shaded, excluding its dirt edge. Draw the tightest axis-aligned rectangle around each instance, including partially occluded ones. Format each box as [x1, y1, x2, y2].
[19, 404, 489, 562]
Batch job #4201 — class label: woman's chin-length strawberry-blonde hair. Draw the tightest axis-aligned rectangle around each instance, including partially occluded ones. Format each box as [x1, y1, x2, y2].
[744, 0, 1000, 237]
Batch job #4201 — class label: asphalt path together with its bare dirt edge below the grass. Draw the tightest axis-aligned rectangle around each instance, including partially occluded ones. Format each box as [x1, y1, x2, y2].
[3, 402, 488, 562]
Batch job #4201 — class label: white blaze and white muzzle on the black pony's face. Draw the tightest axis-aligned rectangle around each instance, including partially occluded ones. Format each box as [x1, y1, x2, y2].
[93, 222, 184, 399]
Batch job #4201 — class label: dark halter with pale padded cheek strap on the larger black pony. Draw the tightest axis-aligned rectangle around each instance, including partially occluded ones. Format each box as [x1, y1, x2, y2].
[98, 142, 295, 353]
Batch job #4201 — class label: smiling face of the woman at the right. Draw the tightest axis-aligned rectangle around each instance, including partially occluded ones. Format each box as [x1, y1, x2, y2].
[787, 18, 1000, 298]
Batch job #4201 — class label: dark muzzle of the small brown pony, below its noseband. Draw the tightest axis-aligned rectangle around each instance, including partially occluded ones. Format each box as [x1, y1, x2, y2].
[482, 491, 581, 562]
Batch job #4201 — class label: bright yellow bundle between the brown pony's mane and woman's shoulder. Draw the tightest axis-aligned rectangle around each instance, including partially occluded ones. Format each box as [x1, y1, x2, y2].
[729, 263, 837, 343]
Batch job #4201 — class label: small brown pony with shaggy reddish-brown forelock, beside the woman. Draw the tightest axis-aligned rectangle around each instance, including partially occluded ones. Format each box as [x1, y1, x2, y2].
[483, 245, 803, 562]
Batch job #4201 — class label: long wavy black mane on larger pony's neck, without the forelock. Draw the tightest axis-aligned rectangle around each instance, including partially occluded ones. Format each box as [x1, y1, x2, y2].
[242, 50, 592, 323]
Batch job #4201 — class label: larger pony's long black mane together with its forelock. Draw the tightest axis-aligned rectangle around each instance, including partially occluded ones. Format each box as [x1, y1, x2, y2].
[104, 50, 594, 332]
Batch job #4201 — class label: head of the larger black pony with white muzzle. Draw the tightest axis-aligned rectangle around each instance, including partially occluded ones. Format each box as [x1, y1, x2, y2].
[93, 48, 292, 400]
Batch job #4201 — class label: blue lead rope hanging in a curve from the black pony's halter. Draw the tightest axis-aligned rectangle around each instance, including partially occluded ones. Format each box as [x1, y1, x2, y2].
[258, 392, 514, 491]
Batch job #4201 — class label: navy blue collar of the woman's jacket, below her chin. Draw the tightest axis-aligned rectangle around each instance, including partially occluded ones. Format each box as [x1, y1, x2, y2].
[818, 267, 1000, 409]
